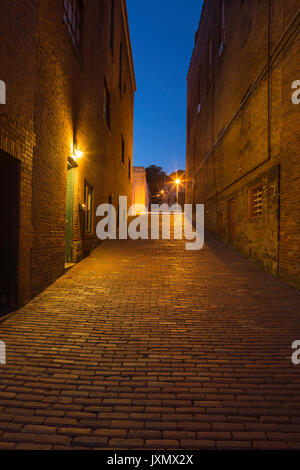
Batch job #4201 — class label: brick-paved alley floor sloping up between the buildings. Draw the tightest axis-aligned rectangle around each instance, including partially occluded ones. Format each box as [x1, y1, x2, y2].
[0, 229, 300, 449]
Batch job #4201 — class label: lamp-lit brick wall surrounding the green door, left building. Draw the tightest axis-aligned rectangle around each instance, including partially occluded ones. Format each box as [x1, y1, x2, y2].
[31, 0, 135, 294]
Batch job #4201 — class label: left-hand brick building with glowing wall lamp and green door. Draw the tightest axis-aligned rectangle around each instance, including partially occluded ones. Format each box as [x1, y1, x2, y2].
[0, 0, 136, 311]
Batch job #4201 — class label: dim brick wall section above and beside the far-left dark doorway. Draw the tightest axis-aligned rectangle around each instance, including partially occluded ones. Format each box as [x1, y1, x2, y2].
[0, 0, 37, 304]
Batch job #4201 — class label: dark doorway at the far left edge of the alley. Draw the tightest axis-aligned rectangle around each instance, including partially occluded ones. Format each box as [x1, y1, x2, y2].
[0, 151, 20, 315]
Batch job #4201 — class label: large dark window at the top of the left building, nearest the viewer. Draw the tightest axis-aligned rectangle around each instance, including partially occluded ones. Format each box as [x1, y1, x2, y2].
[63, 0, 83, 53]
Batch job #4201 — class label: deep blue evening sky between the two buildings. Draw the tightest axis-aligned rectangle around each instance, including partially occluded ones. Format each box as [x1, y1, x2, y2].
[127, 0, 203, 173]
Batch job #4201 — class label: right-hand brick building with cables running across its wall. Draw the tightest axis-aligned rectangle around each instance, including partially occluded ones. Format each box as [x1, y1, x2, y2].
[187, 0, 300, 288]
